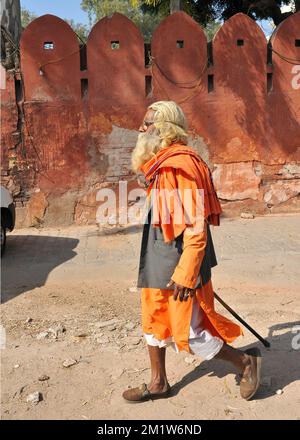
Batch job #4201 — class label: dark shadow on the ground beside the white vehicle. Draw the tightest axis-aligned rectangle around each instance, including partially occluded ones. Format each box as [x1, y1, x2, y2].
[1, 235, 79, 303]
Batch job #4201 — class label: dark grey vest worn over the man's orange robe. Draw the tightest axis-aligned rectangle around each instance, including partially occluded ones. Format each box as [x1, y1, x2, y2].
[137, 210, 218, 289]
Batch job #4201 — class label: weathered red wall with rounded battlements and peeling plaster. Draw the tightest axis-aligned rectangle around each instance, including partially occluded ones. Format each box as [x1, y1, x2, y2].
[1, 12, 300, 226]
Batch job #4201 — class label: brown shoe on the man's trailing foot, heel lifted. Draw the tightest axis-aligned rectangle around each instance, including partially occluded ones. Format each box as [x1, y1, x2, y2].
[240, 348, 261, 400]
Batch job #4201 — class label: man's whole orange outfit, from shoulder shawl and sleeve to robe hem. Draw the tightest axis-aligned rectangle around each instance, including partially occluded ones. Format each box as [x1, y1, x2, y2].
[141, 145, 243, 352]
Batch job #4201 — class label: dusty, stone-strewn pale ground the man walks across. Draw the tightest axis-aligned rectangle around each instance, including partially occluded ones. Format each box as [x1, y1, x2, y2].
[1, 216, 300, 419]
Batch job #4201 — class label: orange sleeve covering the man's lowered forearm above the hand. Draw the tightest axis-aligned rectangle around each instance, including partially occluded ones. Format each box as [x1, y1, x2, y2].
[171, 224, 207, 289]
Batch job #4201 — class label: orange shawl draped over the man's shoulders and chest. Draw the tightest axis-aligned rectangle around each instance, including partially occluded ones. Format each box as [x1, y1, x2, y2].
[141, 144, 222, 242]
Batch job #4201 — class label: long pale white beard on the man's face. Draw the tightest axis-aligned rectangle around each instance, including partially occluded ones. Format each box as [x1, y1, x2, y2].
[131, 130, 161, 173]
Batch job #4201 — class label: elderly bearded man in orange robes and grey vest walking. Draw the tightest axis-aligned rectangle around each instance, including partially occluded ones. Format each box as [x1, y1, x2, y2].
[123, 101, 261, 402]
